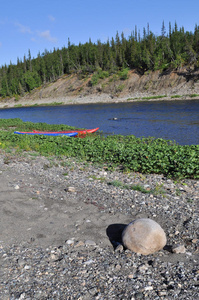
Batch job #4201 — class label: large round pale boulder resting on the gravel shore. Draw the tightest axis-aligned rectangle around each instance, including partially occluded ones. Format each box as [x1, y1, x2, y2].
[122, 219, 167, 255]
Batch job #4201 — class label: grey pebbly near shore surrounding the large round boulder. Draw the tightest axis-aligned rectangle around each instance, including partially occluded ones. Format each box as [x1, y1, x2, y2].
[0, 152, 199, 300]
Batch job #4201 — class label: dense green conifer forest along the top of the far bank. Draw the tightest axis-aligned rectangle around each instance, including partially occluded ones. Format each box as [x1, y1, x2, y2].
[0, 22, 199, 97]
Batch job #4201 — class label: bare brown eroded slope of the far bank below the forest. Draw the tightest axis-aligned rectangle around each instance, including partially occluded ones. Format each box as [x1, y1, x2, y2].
[0, 68, 199, 108]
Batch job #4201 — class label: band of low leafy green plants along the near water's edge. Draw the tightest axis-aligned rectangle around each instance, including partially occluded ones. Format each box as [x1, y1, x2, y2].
[0, 119, 199, 179]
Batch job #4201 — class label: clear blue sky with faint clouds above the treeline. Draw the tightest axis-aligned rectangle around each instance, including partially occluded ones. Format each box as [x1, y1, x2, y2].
[0, 0, 199, 66]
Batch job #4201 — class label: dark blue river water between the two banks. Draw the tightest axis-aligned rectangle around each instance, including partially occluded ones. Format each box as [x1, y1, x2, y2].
[0, 100, 199, 145]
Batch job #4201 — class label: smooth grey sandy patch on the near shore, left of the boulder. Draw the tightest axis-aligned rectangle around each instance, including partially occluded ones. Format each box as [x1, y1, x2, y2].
[0, 158, 131, 246]
